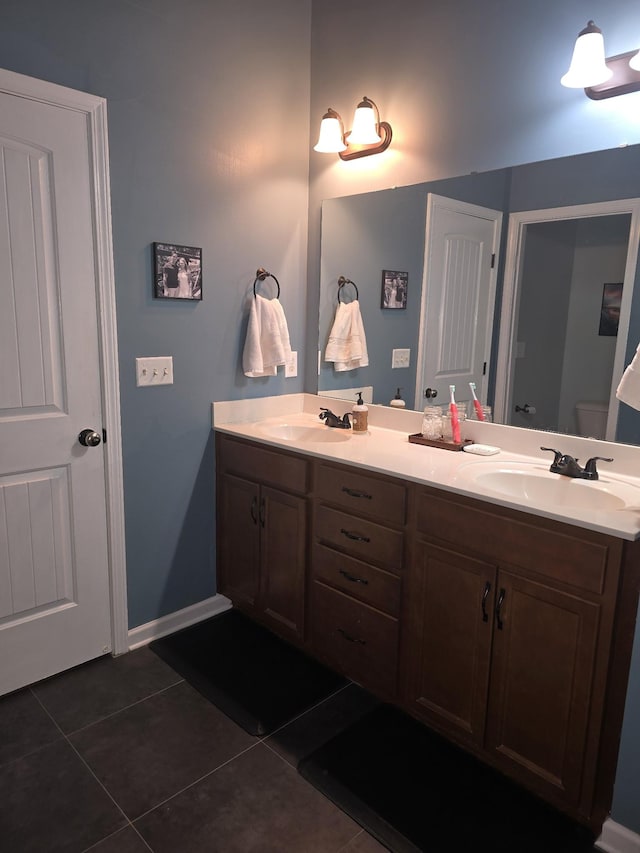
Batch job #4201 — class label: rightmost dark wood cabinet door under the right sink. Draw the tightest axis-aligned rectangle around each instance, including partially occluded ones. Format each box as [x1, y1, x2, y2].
[486, 572, 600, 804]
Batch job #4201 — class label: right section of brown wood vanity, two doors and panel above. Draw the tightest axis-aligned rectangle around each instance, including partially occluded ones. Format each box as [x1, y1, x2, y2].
[402, 489, 623, 819]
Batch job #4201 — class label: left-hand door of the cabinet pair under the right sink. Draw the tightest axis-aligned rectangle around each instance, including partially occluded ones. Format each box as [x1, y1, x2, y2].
[405, 540, 496, 745]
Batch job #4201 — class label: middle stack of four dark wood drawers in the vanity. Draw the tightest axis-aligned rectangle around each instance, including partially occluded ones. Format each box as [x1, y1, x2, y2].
[309, 462, 407, 698]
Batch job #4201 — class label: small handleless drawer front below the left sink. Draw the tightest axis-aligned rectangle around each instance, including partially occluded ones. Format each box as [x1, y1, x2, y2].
[216, 433, 309, 494]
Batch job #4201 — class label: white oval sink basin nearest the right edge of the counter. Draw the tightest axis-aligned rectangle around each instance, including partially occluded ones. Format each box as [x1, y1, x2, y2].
[461, 463, 640, 512]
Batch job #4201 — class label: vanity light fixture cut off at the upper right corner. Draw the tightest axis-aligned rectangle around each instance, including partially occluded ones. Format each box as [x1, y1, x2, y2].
[560, 21, 640, 101]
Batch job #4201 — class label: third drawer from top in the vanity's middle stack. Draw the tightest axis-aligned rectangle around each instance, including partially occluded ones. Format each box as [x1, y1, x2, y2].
[312, 542, 400, 617]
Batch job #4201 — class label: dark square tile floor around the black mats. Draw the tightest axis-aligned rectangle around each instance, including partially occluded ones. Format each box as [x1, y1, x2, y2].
[0, 648, 384, 853]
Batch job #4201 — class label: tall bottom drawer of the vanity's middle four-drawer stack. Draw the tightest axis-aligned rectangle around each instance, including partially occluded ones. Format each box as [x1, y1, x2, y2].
[312, 581, 398, 695]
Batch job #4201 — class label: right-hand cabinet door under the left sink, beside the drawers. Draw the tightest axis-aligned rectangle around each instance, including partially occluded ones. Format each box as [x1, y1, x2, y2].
[260, 486, 307, 640]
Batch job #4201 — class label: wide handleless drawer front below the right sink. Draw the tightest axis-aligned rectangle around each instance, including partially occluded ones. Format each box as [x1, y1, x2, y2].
[417, 491, 620, 594]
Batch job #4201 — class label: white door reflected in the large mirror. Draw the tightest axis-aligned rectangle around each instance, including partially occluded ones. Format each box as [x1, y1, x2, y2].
[415, 193, 502, 409]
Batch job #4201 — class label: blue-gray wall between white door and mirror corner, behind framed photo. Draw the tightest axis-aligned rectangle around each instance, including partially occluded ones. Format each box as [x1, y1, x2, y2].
[0, 0, 310, 627]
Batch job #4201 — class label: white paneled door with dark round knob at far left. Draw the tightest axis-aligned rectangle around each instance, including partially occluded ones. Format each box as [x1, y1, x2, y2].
[0, 80, 112, 694]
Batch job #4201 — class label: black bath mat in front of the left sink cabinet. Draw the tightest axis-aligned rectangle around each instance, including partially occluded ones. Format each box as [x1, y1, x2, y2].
[149, 610, 347, 736]
